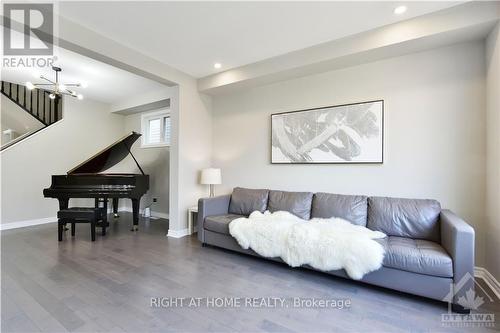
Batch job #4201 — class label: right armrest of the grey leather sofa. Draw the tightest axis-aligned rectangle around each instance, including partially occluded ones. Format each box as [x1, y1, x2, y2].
[440, 209, 474, 304]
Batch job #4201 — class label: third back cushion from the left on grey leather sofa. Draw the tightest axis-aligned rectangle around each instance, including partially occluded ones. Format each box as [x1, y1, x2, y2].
[311, 193, 368, 226]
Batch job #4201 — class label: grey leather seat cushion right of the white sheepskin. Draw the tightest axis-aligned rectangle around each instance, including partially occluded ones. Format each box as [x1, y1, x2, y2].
[377, 236, 453, 277]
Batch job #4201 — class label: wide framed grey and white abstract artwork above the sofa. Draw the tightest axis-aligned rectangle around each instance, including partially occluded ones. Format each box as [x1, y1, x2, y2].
[271, 100, 384, 164]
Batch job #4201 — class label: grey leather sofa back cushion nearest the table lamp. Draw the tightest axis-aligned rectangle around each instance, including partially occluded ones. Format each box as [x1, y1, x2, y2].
[229, 187, 269, 215]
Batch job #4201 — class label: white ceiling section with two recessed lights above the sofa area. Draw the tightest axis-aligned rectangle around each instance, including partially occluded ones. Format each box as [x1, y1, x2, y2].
[59, 1, 463, 77]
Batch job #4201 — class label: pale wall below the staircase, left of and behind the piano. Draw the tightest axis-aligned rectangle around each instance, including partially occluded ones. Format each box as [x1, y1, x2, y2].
[0, 98, 124, 224]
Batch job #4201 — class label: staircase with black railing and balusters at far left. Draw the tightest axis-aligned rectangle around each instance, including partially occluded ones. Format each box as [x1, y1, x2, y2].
[1, 81, 62, 150]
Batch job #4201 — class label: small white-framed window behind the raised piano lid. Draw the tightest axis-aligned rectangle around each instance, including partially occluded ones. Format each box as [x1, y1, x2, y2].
[141, 109, 171, 147]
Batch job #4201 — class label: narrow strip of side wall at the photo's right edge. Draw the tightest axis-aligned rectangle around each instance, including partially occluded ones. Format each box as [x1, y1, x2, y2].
[485, 24, 500, 281]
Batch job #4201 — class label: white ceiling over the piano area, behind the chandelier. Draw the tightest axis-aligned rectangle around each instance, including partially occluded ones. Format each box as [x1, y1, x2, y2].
[2, 43, 165, 104]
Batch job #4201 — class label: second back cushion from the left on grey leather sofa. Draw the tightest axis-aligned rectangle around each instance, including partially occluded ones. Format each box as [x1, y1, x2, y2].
[267, 191, 313, 220]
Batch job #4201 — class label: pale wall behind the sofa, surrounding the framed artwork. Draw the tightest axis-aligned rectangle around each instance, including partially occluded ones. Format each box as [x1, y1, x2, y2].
[213, 42, 486, 264]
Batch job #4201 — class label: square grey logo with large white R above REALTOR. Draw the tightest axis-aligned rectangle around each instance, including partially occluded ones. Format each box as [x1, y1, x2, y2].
[3, 3, 54, 56]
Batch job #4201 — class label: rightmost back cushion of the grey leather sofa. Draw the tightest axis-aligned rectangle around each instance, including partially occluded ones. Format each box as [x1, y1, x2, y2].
[368, 197, 441, 242]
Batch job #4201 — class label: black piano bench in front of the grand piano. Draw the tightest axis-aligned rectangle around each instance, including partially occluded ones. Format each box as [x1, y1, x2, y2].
[57, 207, 106, 242]
